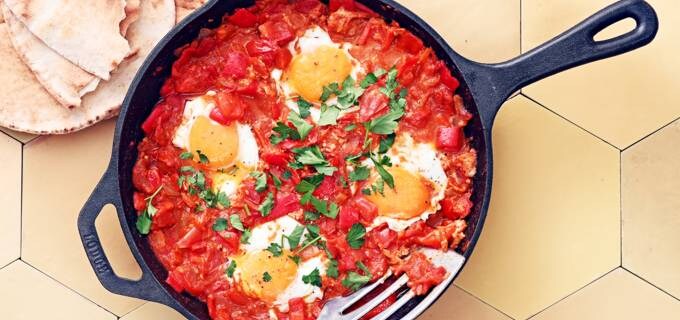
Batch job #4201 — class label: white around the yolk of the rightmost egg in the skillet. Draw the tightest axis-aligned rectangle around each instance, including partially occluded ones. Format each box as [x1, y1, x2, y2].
[363, 133, 449, 231]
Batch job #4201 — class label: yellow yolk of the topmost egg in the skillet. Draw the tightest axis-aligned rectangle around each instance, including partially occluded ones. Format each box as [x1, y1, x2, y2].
[287, 46, 352, 102]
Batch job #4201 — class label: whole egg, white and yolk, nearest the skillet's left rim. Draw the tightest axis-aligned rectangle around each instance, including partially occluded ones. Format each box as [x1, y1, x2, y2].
[172, 91, 260, 196]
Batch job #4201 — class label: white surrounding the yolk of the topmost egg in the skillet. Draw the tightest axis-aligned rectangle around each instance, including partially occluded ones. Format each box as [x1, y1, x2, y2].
[271, 26, 365, 123]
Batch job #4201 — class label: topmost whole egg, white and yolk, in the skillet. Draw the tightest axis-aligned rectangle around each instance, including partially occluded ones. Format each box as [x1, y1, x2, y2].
[271, 26, 365, 122]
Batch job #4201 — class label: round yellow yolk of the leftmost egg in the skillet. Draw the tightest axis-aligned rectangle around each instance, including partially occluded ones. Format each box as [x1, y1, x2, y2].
[189, 116, 239, 166]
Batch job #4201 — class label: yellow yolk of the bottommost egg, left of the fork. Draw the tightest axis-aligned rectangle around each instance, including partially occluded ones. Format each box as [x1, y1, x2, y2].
[234, 250, 297, 303]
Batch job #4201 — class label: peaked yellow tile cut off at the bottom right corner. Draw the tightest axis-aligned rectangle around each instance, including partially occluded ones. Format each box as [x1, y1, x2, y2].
[531, 269, 680, 320]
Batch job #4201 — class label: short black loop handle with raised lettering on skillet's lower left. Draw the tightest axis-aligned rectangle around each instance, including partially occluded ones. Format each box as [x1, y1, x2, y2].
[78, 168, 167, 303]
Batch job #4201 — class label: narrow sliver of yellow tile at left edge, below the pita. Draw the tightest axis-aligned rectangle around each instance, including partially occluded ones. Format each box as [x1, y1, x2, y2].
[0, 133, 21, 267]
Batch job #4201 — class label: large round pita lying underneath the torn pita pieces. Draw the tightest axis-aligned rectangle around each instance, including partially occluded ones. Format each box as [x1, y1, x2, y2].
[0, 0, 175, 134]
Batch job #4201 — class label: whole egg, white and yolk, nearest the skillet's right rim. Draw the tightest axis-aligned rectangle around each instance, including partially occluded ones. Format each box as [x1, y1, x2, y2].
[365, 134, 448, 231]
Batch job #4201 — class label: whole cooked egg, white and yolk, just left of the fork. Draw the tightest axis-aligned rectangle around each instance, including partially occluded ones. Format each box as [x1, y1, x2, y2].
[228, 216, 328, 312]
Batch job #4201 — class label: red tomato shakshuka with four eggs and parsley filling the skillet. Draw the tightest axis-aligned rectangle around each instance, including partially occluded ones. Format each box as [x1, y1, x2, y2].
[133, 0, 477, 320]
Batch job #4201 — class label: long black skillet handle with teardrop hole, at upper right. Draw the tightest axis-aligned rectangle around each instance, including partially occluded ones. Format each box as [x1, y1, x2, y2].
[461, 0, 659, 128]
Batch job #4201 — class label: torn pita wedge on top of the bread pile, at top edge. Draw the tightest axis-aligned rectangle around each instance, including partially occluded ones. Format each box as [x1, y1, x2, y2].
[5, 0, 130, 80]
